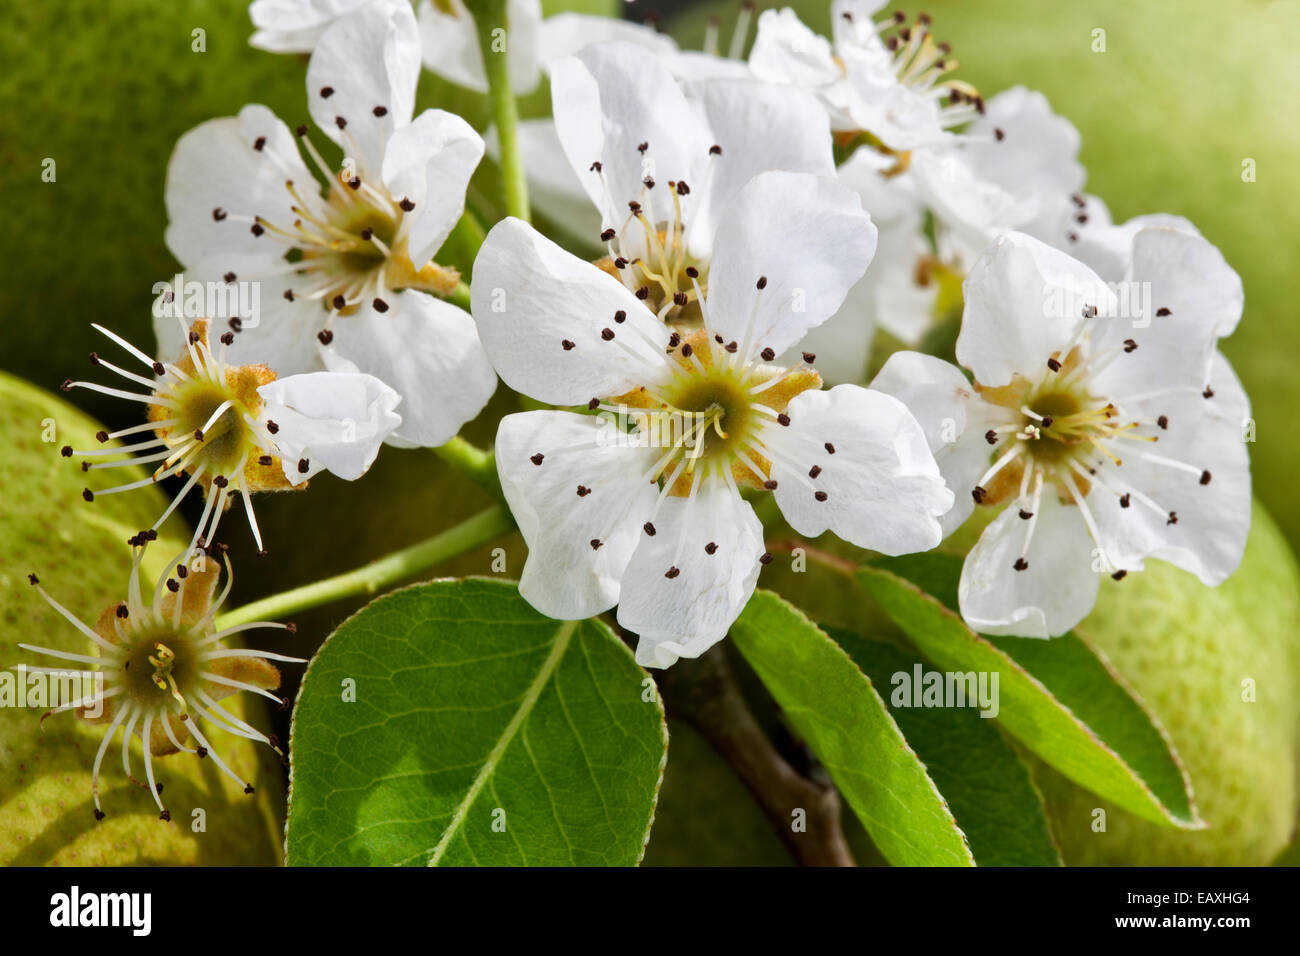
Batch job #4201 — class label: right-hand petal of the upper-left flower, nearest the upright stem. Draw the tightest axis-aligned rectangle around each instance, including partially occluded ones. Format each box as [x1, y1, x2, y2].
[384, 109, 484, 269]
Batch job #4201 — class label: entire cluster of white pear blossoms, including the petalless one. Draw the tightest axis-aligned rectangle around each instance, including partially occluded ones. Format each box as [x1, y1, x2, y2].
[33, 0, 1251, 818]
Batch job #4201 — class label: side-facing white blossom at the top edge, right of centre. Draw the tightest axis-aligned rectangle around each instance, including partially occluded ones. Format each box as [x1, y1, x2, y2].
[749, 0, 983, 152]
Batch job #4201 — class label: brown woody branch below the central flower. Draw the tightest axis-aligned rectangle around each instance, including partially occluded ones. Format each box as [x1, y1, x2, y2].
[659, 648, 855, 866]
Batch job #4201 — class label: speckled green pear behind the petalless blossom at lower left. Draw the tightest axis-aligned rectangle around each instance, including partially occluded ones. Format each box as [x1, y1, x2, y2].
[0, 375, 283, 866]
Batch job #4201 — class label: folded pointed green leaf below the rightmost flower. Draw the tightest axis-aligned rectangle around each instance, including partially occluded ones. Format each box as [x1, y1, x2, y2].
[859, 553, 1204, 829]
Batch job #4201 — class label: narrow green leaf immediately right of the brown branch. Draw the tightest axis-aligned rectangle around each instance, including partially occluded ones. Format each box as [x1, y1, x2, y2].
[731, 591, 975, 866]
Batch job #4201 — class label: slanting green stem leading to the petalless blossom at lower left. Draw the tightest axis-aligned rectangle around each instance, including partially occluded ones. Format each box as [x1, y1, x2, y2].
[216, 505, 514, 628]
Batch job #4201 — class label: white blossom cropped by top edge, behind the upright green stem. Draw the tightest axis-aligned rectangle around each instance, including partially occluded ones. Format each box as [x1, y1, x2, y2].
[419, 0, 542, 94]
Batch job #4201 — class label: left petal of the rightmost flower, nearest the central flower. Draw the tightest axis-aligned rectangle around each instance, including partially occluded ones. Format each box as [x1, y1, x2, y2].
[871, 351, 1009, 537]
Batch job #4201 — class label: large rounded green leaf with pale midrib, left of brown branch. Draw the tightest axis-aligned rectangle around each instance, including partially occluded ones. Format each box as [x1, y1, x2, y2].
[287, 580, 668, 866]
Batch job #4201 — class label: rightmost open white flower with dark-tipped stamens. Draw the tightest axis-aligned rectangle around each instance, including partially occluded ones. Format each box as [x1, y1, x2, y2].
[872, 226, 1251, 637]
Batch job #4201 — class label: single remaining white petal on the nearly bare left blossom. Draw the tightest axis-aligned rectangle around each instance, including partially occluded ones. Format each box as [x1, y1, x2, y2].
[257, 372, 402, 485]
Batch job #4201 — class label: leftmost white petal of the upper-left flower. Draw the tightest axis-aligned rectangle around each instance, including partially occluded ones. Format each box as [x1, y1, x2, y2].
[166, 104, 315, 265]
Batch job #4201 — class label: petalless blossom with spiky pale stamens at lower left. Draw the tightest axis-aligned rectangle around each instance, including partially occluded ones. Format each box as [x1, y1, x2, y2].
[18, 540, 304, 821]
